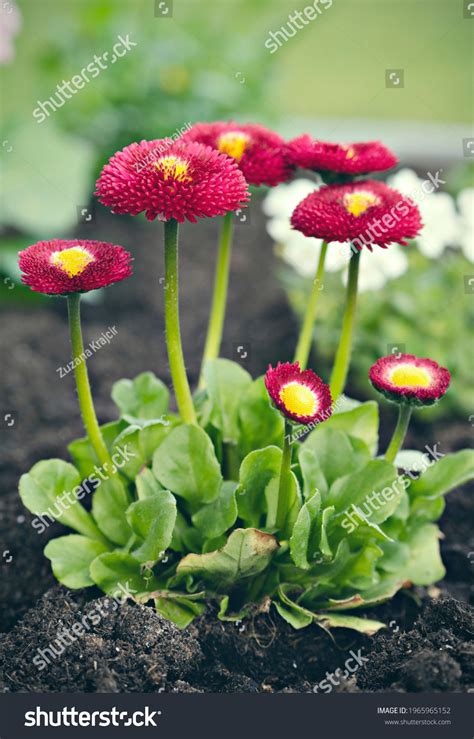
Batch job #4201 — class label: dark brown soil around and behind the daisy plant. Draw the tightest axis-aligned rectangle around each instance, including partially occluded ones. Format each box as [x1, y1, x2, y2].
[0, 207, 474, 692]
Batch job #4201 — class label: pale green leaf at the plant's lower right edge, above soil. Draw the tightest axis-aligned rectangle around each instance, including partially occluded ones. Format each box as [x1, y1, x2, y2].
[403, 523, 446, 585]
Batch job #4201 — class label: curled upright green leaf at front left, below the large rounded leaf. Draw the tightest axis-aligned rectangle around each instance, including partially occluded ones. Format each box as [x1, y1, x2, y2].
[126, 490, 176, 564]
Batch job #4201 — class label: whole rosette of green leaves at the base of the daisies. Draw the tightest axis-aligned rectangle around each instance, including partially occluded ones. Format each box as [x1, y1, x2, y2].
[20, 368, 474, 634]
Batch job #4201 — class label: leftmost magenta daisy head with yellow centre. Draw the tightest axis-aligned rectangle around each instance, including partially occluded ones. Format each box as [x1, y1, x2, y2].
[19, 239, 132, 295]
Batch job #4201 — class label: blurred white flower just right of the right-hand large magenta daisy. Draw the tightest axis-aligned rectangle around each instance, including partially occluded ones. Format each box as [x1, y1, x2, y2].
[388, 169, 459, 259]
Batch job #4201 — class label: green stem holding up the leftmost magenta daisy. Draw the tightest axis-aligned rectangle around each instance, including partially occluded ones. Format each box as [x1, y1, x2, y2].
[67, 293, 114, 471]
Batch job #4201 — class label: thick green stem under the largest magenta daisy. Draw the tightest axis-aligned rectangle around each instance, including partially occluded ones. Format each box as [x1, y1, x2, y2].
[165, 218, 197, 424]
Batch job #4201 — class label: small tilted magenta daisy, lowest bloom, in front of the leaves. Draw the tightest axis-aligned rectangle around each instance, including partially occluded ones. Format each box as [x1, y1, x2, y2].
[265, 362, 332, 424]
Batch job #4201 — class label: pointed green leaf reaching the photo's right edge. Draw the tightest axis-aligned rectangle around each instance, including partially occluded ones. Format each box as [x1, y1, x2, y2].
[409, 444, 474, 498]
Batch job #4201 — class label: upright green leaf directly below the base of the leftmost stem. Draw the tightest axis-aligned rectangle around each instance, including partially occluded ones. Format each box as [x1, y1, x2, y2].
[92, 475, 132, 546]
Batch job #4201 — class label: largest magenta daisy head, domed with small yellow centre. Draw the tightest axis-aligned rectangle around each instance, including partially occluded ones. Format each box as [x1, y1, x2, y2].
[95, 139, 249, 223]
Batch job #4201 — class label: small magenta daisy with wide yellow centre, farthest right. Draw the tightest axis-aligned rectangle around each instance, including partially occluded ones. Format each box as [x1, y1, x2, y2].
[369, 354, 451, 406]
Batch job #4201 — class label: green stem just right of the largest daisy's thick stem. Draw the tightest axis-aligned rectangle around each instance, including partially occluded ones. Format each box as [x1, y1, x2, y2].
[199, 211, 234, 388]
